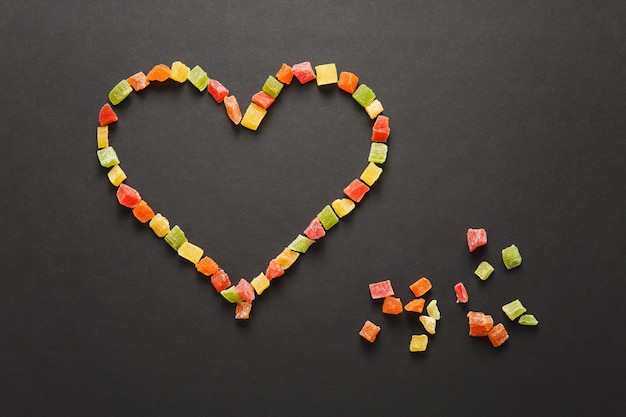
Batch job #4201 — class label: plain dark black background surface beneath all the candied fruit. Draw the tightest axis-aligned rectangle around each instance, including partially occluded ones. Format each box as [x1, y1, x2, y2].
[0, 0, 626, 416]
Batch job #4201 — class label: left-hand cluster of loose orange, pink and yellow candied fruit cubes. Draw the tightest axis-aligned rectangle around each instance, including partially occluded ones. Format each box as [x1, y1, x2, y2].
[359, 277, 441, 352]
